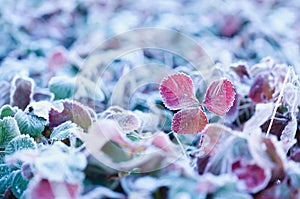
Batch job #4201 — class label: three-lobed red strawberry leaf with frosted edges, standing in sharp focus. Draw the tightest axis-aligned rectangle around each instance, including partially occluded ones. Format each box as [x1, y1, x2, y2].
[160, 73, 235, 134]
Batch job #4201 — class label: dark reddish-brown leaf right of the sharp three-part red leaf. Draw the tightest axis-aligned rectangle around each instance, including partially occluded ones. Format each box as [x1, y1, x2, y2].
[248, 75, 275, 103]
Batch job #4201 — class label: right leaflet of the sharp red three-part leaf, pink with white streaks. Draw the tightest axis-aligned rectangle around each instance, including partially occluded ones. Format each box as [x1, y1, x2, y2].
[203, 79, 235, 116]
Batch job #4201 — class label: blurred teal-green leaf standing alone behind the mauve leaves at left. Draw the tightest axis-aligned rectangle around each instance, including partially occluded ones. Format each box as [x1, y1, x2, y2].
[49, 76, 76, 100]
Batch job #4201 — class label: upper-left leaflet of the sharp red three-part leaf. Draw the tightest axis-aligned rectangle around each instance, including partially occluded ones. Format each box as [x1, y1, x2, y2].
[160, 73, 199, 110]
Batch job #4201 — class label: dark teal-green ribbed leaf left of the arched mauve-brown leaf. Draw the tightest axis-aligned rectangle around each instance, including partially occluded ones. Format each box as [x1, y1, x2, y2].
[15, 111, 48, 137]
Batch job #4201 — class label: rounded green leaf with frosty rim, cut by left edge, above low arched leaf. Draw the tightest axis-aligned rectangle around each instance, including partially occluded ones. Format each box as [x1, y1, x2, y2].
[0, 117, 20, 149]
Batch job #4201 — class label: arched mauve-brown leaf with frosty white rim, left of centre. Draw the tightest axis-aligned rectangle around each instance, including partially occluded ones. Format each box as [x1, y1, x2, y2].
[49, 100, 92, 131]
